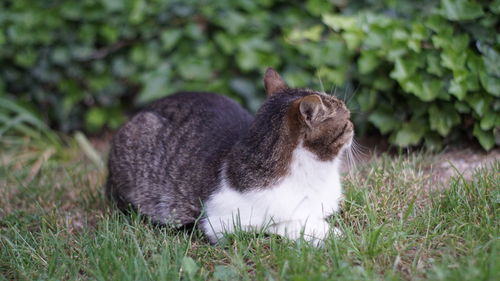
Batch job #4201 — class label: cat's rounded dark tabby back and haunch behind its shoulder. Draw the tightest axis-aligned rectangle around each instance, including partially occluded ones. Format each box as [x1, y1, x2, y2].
[107, 92, 252, 224]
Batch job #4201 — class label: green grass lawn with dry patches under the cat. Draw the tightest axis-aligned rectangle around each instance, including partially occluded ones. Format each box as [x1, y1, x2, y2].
[0, 140, 500, 281]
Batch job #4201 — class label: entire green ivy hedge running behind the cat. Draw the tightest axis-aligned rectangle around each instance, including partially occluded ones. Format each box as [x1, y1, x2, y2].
[0, 0, 500, 149]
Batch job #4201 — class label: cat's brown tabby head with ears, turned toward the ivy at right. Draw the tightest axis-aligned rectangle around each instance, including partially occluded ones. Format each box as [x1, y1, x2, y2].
[264, 68, 354, 161]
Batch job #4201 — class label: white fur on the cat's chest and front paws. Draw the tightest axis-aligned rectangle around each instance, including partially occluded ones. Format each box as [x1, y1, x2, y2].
[201, 145, 342, 244]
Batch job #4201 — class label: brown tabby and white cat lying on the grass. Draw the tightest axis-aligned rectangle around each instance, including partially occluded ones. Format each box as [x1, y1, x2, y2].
[106, 68, 354, 244]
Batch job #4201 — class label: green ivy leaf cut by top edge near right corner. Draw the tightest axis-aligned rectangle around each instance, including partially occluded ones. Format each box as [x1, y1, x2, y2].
[441, 0, 484, 21]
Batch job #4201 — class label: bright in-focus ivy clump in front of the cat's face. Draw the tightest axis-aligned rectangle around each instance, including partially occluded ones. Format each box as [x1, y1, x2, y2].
[320, 0, 500, 150]
